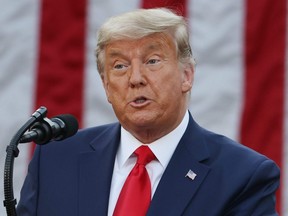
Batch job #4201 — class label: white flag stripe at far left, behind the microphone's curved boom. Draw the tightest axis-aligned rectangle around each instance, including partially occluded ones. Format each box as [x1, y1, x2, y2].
[0, 0, 39, 215]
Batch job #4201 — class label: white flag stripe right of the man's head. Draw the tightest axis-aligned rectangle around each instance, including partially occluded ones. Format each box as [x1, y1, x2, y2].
[188, 0, 244, 139]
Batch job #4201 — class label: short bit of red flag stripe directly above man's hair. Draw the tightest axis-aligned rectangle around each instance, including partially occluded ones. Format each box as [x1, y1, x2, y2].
[141, 0, 187, 16]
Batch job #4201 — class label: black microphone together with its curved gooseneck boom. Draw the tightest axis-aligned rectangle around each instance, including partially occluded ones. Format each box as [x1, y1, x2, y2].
[3, 106, 78, 216]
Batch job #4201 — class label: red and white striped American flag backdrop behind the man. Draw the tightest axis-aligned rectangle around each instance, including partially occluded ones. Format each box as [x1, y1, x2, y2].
[0, 0, 288, 216]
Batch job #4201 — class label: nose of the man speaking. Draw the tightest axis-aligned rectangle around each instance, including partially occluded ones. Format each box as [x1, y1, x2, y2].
[129, 61, 147, 88]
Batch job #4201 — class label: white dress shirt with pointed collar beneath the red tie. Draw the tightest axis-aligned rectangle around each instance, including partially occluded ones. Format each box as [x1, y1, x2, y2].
[108, 111, 189, 216]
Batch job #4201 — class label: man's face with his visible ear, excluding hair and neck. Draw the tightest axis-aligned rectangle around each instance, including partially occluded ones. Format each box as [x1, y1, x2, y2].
[102, 33, 193, 140]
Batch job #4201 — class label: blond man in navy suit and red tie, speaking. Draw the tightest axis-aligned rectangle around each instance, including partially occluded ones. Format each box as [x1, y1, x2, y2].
[17, 9, 279, 216]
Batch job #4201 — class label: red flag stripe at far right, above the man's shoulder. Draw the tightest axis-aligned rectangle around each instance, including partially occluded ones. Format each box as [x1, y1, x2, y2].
[240, 0, 286, 211]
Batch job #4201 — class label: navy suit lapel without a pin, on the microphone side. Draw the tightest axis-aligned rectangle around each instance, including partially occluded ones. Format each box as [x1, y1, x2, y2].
[78, 125, 120, 216]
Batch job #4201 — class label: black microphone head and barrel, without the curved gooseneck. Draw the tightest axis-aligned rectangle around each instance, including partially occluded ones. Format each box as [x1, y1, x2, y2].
[20, 114, 78, 145]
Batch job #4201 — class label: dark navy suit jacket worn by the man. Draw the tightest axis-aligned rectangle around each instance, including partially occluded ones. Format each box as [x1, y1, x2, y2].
[17, 116, 279, 216]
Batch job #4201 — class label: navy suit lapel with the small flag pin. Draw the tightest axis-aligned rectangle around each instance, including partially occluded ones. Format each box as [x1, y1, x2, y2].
[147, 115, 210, 216]
